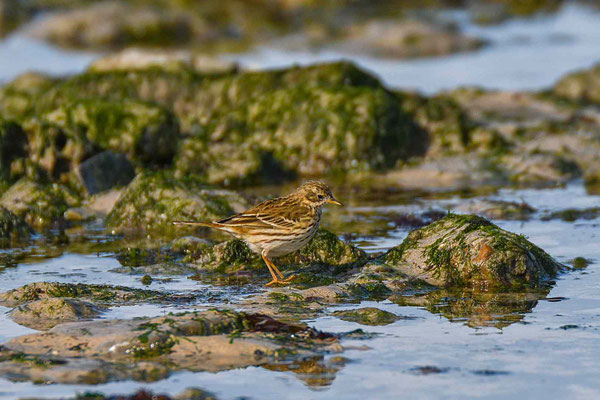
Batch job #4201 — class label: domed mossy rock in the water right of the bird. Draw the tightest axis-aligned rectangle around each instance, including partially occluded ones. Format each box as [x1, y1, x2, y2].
[380, 214, 563, 288]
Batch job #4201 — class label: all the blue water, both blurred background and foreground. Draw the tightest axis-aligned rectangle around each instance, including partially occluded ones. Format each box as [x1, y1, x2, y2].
[0, 5, 600, 399]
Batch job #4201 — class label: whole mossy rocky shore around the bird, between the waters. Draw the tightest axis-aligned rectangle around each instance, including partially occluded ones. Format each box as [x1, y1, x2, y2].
[0, 36, 600, 384]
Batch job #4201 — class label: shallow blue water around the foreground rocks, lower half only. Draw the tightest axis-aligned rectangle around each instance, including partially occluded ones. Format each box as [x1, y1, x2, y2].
[0, 183, 600, 399]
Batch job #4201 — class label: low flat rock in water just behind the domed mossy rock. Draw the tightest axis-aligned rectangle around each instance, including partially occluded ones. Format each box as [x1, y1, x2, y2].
[454, 199, 536, 220]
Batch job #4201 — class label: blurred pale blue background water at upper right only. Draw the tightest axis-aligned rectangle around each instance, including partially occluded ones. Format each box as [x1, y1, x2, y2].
[233, 4, 600, 93]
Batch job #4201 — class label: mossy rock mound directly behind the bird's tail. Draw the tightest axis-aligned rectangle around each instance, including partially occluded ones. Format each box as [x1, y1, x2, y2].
[107, 173, 249, 233]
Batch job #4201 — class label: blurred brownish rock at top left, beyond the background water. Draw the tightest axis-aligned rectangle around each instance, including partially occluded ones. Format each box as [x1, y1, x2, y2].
[25, 0, 290, 52]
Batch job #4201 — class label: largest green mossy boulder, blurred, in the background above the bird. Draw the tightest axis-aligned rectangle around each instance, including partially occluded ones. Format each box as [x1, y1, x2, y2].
[176, 63, 424, 183]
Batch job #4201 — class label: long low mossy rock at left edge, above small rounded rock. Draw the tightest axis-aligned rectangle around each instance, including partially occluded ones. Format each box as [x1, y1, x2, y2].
[0, 282, 160, 307]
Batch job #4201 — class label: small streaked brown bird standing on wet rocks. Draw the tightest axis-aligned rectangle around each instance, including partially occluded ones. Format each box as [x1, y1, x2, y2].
[174, 181, 342, 286]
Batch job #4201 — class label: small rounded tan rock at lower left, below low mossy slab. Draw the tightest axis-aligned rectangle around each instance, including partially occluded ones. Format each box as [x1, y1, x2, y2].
[10, 298, 102, 330]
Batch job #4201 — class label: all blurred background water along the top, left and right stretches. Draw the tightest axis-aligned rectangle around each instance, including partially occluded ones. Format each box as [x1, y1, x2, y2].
[0, 3, 600, 93]
